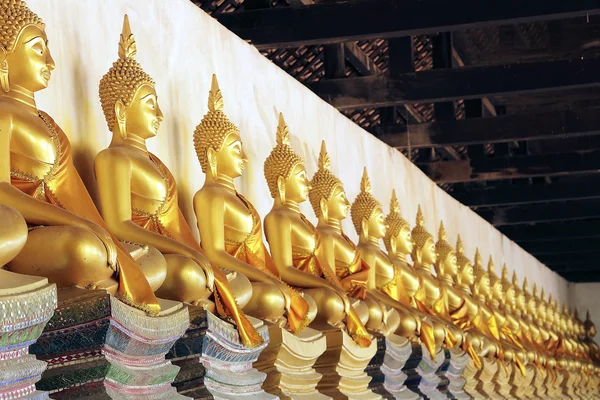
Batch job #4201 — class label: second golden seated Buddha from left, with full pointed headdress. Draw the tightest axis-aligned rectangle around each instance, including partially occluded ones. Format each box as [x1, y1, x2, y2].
[94, 16, 262, 347]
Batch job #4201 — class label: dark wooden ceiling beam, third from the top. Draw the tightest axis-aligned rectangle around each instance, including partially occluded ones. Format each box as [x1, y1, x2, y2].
[375, 108, 600, 149]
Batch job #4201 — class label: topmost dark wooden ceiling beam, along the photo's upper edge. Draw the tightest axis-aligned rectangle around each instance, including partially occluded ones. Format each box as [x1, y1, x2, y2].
[216, 0, 600, 49]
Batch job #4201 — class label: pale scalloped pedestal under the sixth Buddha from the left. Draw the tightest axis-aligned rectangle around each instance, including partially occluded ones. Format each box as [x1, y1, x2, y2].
[381, 335, 419, 400]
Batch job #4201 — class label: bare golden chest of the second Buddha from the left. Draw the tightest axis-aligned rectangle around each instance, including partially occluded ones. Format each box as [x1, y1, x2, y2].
[131, 154, 167, 202]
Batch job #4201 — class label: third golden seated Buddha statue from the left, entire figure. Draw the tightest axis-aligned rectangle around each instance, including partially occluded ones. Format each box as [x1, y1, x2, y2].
[194, 75, 316, 333]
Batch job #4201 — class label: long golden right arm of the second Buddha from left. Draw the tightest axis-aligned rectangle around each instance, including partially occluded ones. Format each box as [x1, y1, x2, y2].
[94, 148, 214, 288]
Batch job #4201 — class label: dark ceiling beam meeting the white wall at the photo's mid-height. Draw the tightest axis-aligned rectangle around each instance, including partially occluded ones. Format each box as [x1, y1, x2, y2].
[478, 200, 600, 227]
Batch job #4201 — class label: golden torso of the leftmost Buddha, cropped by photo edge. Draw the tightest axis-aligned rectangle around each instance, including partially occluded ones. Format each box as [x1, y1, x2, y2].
[6, 102, 61, 179]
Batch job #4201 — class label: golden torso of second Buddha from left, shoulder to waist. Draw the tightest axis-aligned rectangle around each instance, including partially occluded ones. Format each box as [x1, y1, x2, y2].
[121, 148, 168, 214]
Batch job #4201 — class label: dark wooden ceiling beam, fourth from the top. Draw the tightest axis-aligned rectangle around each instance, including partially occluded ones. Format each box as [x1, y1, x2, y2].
[417, 150, 600, 183]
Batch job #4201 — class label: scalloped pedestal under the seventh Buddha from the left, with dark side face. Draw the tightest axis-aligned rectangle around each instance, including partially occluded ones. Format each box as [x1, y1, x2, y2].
[404, 343, 447, 399]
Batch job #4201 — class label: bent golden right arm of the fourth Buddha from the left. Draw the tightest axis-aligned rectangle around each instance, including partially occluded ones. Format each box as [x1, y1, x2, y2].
[265, 212, 337, 292]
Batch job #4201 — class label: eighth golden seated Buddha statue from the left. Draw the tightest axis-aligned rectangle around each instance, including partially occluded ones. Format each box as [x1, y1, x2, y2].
[411, 205, 464, 348]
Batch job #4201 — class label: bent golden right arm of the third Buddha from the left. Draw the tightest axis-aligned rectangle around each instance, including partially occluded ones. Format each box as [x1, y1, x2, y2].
[194, 190, 285, 292]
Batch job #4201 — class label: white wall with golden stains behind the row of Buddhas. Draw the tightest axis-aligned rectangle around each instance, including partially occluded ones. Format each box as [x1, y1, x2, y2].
[27, 0, 567, 301]
